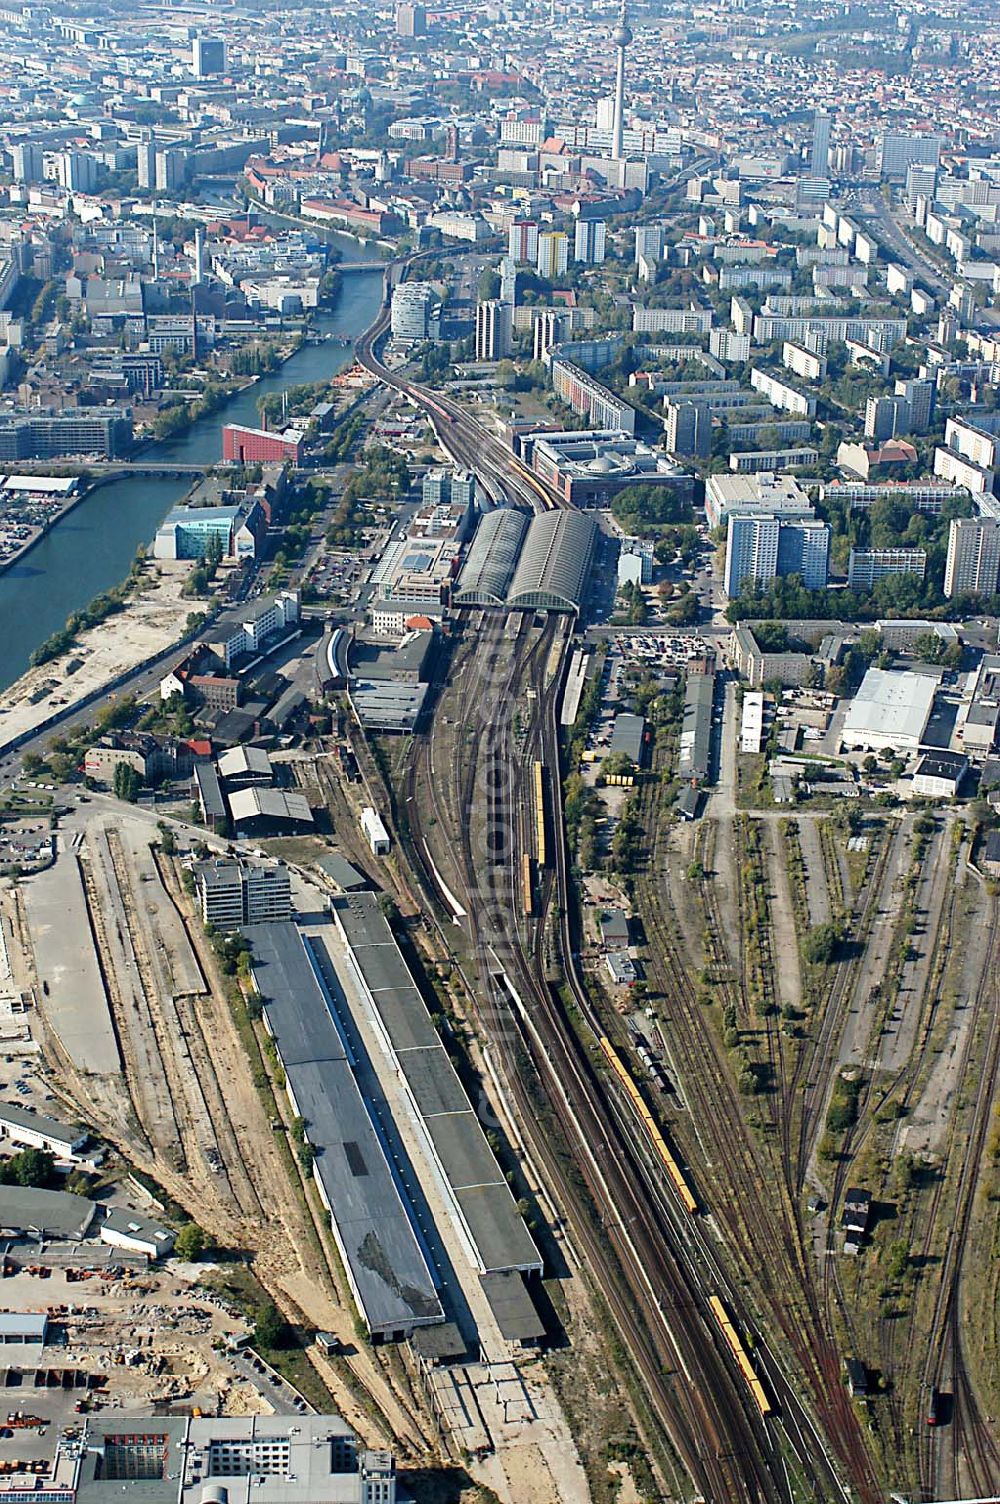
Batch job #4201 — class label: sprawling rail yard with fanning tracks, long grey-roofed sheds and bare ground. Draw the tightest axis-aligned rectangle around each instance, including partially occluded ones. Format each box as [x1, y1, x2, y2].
[2, 243, 1000, 1504]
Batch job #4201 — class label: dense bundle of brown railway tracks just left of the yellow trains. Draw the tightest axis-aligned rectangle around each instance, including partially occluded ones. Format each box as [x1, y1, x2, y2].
[400, 625, 785, 1501]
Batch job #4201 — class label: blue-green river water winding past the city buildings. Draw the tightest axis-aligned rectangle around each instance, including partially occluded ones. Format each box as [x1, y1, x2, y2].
[0, 255, 383, 689]
